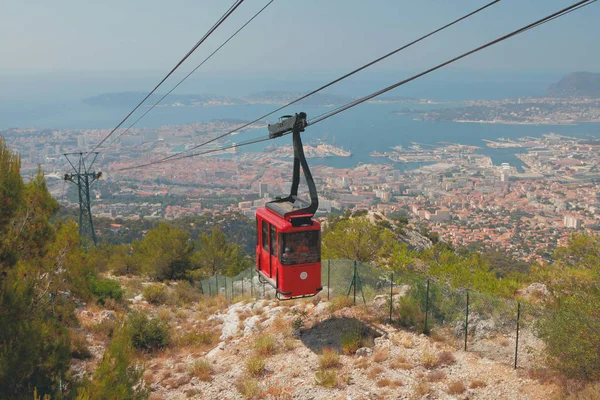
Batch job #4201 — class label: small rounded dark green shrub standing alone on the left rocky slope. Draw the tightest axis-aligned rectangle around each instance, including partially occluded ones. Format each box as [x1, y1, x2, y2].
[128, 311, 171, 350]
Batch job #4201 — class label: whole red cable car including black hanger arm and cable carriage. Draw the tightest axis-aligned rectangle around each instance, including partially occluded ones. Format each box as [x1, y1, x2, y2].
[256, 113, 323, 300]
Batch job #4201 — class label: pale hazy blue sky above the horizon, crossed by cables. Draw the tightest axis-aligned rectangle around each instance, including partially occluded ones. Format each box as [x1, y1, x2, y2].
[0, 0, 600, 95]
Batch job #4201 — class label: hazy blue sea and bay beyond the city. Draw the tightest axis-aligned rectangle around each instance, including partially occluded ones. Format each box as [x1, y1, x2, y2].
[0, 74, 600, 170]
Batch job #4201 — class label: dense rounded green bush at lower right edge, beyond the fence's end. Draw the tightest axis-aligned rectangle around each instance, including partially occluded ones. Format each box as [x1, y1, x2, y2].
[538, 294, 600, 381]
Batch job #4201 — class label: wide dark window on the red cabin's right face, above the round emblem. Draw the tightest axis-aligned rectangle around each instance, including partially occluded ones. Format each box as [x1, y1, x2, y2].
[279, 231, 321, 265]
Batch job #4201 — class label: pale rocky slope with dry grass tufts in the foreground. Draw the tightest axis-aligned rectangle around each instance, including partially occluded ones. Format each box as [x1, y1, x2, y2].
[73, 278, 561, 400]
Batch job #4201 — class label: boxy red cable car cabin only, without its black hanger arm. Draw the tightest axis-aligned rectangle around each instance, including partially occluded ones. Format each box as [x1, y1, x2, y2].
[256, 208, 323, 299]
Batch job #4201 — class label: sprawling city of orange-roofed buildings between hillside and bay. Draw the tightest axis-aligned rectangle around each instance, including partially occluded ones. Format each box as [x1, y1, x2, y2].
[3, 121, 600, 261]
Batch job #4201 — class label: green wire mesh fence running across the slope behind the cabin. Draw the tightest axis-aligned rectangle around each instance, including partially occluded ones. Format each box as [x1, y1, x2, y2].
[199, 260, 543, 368]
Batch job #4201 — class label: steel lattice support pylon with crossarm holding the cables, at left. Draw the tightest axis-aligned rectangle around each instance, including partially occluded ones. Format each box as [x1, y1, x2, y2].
[64, 152, 102, 249]
